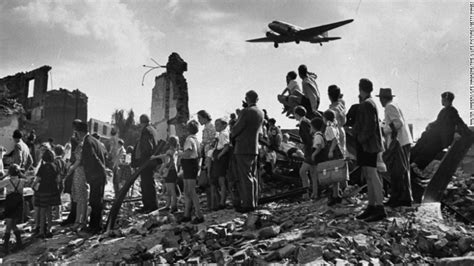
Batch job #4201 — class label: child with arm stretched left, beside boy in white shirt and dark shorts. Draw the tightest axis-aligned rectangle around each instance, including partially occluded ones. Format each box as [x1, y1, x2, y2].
[151, 136, 179, 213]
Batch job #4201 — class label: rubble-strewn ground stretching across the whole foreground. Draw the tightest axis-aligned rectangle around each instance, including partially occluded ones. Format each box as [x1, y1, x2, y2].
[3, 172, 474, 265]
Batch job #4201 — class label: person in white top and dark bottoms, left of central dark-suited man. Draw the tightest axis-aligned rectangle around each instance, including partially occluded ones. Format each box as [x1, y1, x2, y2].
[211, 118, 230, 210]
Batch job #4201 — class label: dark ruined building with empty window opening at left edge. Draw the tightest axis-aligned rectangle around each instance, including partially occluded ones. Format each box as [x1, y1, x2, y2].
[0, 66, 87, 145]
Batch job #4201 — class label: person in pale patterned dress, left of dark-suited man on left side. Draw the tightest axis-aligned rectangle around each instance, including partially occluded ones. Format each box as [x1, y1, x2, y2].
[68, 139, 89, 231]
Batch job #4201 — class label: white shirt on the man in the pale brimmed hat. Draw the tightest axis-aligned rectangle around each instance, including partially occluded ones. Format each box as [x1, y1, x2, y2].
[383, 102, 413, 146]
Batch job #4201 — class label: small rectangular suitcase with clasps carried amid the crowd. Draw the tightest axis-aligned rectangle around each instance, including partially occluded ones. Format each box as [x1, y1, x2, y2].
[316, 159, 349, 185]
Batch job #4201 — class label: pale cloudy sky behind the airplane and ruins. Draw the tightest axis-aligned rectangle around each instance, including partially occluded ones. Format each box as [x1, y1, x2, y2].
[0, 0, 469, 135]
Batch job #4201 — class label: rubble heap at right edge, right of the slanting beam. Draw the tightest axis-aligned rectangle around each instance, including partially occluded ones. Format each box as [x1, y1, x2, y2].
[444, 171, 474, 221]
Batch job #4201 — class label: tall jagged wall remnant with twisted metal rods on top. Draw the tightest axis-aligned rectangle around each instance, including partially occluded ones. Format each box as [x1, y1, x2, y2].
[150, 53, 189, 142]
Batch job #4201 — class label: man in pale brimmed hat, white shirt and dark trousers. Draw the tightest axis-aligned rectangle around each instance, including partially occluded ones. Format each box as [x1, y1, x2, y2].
[377, 88, 413, 207]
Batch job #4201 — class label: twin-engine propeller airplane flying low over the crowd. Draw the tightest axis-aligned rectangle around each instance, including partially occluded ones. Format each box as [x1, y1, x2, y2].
[247, 19, 354, 48]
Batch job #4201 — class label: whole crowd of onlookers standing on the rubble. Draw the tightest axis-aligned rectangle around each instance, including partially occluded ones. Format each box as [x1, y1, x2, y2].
[0, 65, 470, 255]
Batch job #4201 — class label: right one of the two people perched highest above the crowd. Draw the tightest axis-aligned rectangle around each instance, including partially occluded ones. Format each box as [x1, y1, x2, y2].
[298, 65, 321, 118]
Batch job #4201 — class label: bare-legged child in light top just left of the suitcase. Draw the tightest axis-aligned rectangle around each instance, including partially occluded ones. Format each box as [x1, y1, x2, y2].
[311, 117, 327, 198]
